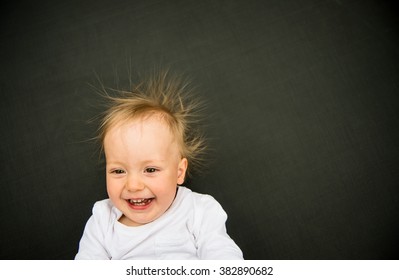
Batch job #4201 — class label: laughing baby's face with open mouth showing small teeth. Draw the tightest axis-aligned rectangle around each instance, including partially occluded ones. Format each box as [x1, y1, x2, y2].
[104, 115, 187, 226]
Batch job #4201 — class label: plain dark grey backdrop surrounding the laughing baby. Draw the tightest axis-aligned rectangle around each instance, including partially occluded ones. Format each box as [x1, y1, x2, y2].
[0, 0, 399, 259]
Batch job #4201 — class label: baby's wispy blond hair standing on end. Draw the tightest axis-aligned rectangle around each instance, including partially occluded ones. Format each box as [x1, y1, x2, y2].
[97, 71, 207, 175]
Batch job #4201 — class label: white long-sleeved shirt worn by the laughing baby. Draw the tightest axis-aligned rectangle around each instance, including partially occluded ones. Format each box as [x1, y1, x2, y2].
[75, 187, 243, 260]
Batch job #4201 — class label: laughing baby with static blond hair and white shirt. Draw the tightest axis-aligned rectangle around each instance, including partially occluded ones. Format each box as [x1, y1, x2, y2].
[75, 74, 243, 260]
